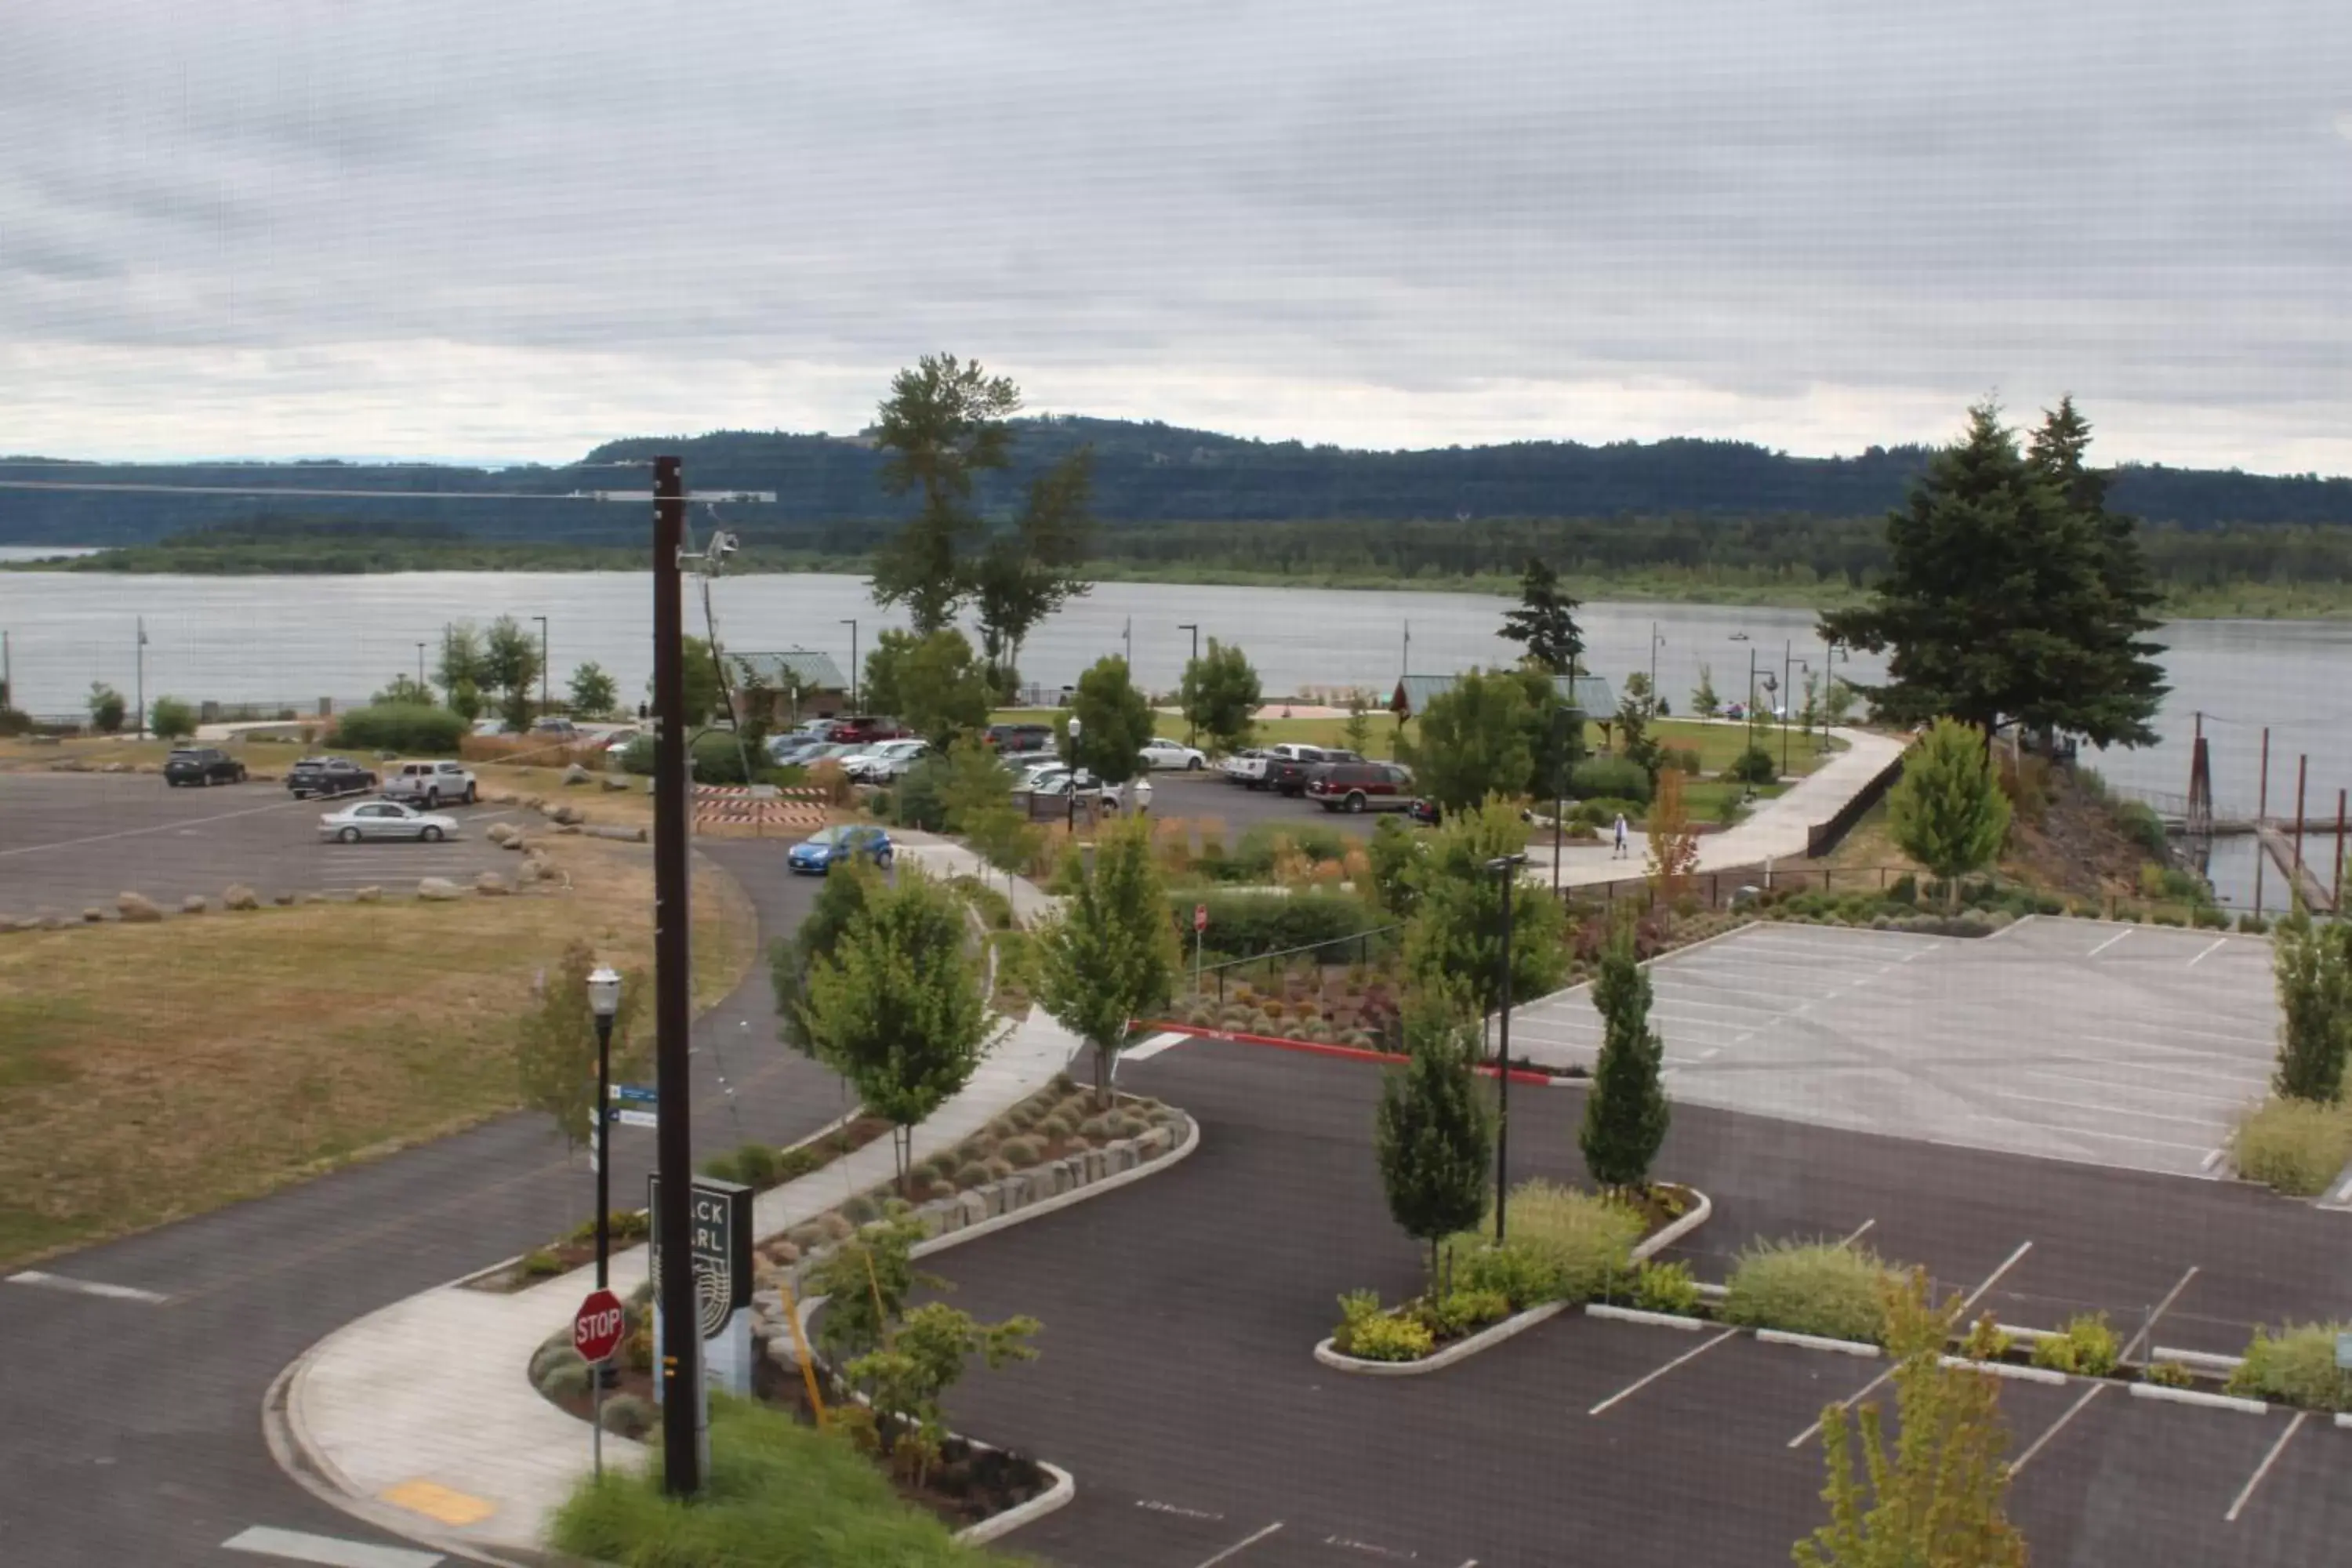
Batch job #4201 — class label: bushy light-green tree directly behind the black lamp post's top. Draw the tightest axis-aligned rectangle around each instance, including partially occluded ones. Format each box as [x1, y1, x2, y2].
[1404, 799, 1569, 1018]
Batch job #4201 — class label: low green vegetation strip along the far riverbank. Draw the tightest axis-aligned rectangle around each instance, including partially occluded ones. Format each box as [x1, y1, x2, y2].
[13, 524, 2352, 621]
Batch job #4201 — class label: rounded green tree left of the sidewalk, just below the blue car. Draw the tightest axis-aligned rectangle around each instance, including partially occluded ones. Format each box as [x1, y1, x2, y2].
[802, 867, 988, 1182]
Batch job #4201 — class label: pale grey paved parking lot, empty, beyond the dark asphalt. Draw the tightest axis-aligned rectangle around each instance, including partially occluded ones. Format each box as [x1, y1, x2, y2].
[1510, 919, 2277, 1175]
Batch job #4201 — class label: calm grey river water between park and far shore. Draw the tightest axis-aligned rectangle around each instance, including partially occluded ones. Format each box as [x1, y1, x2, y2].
[0, 564, 2352, 907]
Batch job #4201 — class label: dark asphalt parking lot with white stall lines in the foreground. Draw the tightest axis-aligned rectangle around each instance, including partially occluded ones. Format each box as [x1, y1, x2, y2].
[934, 1041, 2352, 1568]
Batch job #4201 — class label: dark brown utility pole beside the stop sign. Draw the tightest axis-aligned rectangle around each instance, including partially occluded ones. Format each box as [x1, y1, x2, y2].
[654, 456, 703, 1497]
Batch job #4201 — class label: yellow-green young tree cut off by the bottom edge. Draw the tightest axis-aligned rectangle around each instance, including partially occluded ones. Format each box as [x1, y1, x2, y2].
[1795, 1269, 2025, 1568]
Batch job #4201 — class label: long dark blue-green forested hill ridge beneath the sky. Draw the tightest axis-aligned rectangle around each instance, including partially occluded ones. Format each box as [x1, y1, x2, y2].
[0, 416, 2352, 546]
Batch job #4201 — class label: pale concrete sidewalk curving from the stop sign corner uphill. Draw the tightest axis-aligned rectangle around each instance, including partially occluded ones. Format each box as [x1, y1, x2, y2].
[285, 851, 1082, 1552]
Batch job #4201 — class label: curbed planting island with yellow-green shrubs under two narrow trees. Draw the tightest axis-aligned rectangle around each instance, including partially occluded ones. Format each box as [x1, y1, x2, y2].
[1315, 1180, 1715, 1377]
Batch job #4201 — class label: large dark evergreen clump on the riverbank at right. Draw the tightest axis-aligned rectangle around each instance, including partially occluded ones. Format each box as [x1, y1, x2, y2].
[1820, 405, 2164, 746]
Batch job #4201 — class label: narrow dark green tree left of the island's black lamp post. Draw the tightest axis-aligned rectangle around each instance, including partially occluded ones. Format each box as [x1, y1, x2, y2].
[1371, 1004, 1494, 1290]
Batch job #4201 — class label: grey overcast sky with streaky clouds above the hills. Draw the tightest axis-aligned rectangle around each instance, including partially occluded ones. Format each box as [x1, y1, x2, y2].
[0, 0, 2352, 473]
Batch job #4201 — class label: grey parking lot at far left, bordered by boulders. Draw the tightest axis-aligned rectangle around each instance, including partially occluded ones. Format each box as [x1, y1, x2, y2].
[0, 774, 513, 916]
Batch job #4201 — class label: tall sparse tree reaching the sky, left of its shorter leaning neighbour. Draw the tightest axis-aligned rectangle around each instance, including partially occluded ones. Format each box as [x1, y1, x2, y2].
[873, 355, 1021, 633]
